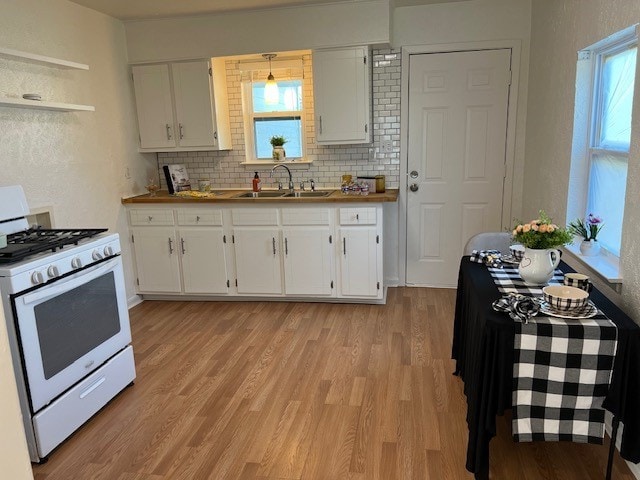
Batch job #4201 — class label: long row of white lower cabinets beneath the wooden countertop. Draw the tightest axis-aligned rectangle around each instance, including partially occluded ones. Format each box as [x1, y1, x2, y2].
[129, 204, 383, 301]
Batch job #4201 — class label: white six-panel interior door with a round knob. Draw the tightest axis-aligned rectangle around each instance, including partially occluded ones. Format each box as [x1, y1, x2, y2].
[406, 49, 511, 287]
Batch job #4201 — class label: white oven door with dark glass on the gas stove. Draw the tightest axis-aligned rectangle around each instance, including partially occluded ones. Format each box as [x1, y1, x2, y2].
[13, 256, 131, 412]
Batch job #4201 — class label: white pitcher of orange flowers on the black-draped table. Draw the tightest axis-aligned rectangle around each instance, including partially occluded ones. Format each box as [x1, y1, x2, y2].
[512, 210, 573, 285]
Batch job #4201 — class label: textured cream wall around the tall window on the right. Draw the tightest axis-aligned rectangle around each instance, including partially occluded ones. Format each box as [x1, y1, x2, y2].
[523, 0, 640, 322]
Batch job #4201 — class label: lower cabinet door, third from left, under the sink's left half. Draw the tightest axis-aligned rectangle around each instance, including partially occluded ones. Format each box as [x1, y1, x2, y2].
[233, 227, 282, 294]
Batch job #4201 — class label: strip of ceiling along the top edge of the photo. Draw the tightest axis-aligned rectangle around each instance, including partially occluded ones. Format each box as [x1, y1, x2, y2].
[71, 0, 465, 20]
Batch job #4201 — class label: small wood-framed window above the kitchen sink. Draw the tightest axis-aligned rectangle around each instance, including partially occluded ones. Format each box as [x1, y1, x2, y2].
[242, 61, 304, 162]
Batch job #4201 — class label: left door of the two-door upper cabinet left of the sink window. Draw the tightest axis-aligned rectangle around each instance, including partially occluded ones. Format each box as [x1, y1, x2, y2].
[132, 65, 176, 148]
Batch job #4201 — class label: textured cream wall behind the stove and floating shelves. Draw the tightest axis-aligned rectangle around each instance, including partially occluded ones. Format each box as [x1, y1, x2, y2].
[0, 0, 155, 304]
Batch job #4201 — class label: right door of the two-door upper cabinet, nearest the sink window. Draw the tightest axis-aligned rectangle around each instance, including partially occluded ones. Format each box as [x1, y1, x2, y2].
[171, 61, 216, 147]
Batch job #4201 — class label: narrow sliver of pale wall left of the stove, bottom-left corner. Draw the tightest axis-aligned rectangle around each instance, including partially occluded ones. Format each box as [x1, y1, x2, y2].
[0, 308, 33, 480]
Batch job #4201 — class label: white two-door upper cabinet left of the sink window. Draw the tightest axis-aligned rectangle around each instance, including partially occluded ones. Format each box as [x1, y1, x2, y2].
[132, 59, 231, 152]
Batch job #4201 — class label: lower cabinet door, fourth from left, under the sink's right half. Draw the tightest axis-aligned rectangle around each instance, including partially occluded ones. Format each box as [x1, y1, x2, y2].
[282, 226, 334, 296]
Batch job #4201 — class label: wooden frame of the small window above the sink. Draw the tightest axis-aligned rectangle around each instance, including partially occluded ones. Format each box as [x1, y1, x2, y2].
[242, 75, 307, 164]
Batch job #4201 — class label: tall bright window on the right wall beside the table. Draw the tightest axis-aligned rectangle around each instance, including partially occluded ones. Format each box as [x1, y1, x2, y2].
[567, 26, 638, 256]
